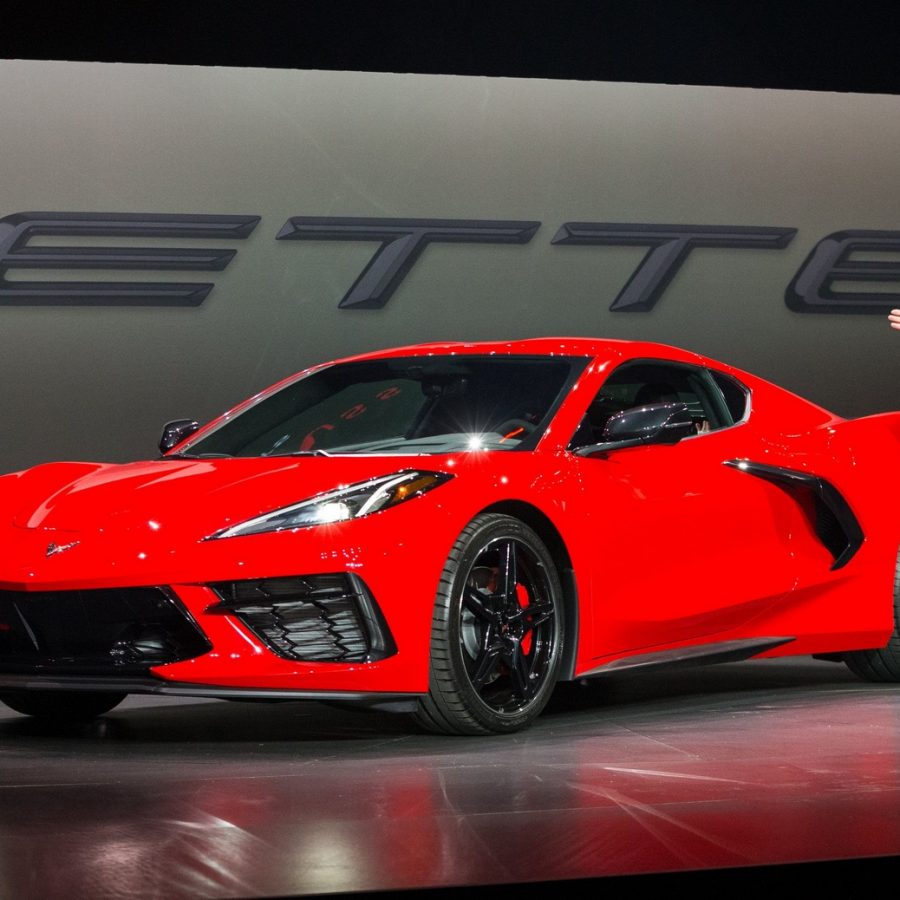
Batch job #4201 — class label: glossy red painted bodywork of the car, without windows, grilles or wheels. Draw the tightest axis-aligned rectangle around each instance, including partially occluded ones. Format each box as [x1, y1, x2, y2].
[0, 338, 900, 732]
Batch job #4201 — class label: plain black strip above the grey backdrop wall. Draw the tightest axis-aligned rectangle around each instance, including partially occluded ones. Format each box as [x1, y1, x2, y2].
[7, 0, 900, 93]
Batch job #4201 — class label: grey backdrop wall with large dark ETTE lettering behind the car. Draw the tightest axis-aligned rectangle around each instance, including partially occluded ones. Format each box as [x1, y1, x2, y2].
[0, 60, 900, 471]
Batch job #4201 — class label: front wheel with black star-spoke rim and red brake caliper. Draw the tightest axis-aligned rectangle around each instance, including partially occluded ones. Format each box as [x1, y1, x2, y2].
[415, 513, 565, 735]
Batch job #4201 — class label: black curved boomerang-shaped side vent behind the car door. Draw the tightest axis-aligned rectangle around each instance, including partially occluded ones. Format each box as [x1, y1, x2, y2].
[725, 459, 865, 569]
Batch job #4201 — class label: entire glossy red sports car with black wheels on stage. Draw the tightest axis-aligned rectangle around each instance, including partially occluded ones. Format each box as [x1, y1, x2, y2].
[0, 338, 900, 734]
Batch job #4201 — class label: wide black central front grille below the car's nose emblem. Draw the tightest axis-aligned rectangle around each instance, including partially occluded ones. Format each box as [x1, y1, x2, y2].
[0, 588, 212, 675]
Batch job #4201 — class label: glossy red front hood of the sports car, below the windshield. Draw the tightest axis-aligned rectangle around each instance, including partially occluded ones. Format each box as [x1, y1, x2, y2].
[0, 456, 441, 540]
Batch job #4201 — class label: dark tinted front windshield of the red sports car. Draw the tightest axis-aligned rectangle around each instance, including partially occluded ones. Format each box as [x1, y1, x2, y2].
[179, 355, 587, 457]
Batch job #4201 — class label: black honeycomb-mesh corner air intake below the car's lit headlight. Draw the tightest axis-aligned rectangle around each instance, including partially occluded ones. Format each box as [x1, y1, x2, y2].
[207, 573, 396, 662]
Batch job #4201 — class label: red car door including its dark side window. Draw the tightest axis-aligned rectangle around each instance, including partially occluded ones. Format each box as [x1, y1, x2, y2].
[571, 360, 802, 659]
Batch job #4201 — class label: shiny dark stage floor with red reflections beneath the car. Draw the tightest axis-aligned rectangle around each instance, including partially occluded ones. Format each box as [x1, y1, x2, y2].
[0, 660, 900, 900]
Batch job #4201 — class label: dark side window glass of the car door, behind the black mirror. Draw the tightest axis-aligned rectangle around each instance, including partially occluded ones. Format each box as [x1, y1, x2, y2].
[569, 360, 736, 448]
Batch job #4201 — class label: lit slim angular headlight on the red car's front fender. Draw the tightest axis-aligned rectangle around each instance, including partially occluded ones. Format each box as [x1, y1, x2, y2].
[207, 471, 453, 540]
